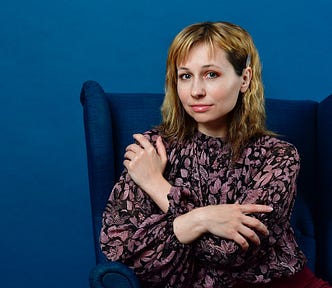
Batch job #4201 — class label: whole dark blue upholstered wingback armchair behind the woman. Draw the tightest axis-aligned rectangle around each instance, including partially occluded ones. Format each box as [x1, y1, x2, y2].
[81, 81, 332, 288]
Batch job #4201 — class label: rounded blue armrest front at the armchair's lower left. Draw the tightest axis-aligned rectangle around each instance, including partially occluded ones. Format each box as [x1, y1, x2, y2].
[89, 262, 140, 288]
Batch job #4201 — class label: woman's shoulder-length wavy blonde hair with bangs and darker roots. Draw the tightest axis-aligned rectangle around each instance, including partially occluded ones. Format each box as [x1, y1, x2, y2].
[160, 22, 273, 158]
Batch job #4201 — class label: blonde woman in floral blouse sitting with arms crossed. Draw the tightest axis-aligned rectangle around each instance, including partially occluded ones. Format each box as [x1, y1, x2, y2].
[100, 22, 330, 288]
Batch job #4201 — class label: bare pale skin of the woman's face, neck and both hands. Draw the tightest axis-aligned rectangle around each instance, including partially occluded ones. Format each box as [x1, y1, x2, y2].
[124, 44, 272, 250]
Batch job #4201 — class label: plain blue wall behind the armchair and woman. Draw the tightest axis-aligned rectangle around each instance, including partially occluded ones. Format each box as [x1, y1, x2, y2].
[0, 0, 332, 288]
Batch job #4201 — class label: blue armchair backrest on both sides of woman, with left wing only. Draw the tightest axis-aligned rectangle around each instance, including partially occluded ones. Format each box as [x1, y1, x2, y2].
[81, 81, 317, 269]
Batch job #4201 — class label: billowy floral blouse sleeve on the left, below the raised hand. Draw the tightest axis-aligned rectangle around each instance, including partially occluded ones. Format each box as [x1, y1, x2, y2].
[100, 171, 193, 283]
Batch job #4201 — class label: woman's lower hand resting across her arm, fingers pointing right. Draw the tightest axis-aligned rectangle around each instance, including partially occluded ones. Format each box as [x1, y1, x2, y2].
[173, 203, 273, 250]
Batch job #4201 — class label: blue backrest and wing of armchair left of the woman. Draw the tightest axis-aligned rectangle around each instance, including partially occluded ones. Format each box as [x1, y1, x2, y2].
[81, 81, 163, 263]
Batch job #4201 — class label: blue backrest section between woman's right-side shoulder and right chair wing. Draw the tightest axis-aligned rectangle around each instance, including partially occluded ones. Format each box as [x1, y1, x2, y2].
[266, 99, 318, 271]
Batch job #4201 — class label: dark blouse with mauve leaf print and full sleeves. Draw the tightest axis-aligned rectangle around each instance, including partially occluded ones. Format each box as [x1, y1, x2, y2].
[100, 129, 306, 288]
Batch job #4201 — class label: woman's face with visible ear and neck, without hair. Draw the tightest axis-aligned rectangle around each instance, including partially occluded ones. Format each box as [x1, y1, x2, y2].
[177, 44, 251, 137]
